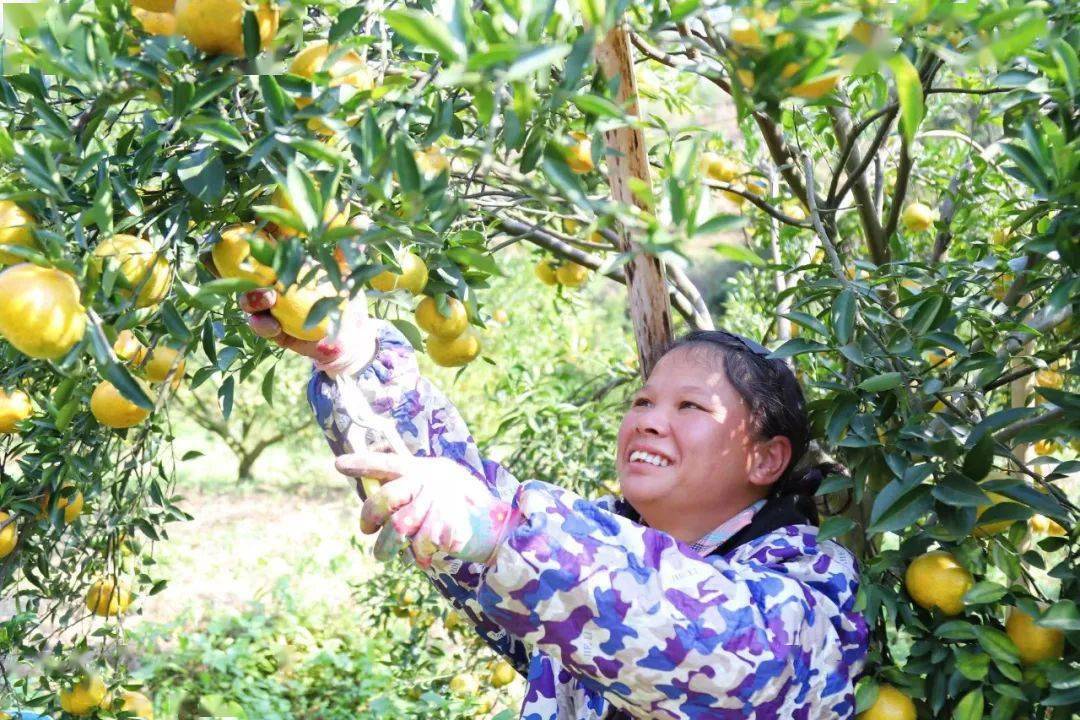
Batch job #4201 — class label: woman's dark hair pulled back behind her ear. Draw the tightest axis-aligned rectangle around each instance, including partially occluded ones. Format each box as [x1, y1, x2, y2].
[663, 330, 846, 525]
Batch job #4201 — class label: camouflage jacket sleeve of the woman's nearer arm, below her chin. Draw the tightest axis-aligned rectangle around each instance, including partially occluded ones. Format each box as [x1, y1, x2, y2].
[477, 481, 865, 719]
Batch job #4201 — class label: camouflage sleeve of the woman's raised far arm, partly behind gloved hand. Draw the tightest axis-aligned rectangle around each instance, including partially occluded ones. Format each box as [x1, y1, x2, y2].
[308, 320, 528, 668]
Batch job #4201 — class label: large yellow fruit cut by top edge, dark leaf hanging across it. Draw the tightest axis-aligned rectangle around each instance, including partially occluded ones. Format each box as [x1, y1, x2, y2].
[176, 0, 281, 57]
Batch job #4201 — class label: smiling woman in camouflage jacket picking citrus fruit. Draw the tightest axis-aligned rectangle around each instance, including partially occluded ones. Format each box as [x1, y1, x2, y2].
[242, 290, 867, 720]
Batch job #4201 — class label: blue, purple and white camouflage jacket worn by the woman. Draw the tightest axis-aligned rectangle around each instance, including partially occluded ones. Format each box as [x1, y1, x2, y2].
[308, 321, 867, 720]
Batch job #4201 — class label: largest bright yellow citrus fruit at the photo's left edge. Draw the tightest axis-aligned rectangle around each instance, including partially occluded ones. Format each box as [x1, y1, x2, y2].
[0, 262, 86, 359]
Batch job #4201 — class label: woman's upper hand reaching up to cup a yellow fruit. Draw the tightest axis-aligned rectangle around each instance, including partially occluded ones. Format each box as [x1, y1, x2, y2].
[240, 288, 375, 375]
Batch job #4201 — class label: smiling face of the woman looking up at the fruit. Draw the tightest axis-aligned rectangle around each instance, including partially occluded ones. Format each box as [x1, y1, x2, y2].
[616, 347, 765, 532]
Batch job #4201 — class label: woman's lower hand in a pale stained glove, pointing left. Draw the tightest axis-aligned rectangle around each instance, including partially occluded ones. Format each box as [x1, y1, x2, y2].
[337, 452, 521, 568]
